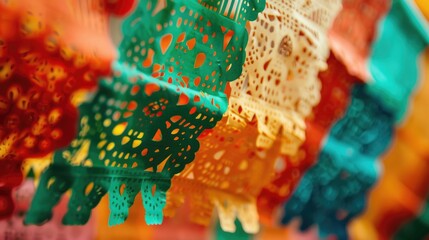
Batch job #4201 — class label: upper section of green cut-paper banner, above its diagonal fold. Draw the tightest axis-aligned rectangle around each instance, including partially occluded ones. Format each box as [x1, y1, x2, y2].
[119, 0, 252, 82]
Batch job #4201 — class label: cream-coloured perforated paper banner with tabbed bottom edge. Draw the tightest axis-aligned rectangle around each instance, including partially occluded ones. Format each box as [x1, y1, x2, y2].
[229, 0, 341, 155]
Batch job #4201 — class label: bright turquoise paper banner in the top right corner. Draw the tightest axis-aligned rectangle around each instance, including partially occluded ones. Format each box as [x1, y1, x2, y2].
[368, 0, 429, 122]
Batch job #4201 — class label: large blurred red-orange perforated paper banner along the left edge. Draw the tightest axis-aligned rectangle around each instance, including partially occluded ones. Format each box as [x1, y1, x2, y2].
[0, 0, 127, 217]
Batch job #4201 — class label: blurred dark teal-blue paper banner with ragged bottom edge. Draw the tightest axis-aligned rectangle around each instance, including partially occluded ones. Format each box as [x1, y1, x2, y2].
[282, 85, 394, 239]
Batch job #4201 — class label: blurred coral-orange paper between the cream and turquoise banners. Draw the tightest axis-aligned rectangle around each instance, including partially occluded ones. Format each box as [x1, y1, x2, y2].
[329, 0, 391, 81]
